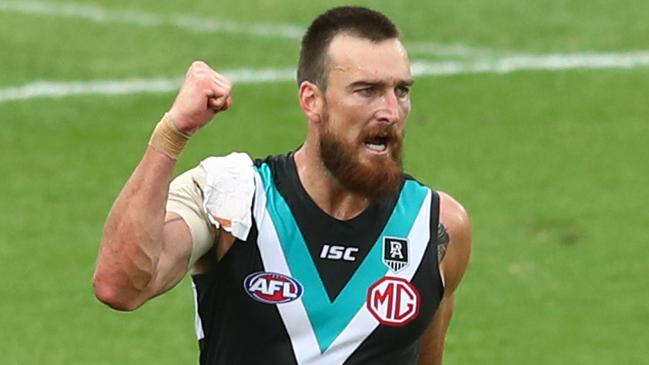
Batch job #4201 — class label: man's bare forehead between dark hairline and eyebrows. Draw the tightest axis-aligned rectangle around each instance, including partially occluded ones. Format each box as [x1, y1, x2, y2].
[328, 34, 412, 83]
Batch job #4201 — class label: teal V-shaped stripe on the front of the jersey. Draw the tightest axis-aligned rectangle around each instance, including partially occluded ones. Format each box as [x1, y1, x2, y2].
[257, 164, 428, 353]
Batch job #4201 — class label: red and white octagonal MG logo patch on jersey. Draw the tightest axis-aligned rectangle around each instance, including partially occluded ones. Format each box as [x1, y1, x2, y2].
[367, 276, 421, 326]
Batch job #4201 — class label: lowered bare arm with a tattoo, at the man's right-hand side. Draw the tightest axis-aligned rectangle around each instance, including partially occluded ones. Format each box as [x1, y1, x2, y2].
[419, 193, 471, 365]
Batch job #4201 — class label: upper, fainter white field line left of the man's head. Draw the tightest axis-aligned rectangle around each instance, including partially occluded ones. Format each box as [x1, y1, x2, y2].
[0, 0, 304, 39]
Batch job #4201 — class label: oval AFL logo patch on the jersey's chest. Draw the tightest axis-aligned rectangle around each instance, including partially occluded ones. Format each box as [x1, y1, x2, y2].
[243, 271, 304, 304]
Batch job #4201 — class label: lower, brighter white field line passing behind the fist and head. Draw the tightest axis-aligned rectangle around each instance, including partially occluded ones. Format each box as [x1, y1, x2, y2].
[0, 51, 649, 103]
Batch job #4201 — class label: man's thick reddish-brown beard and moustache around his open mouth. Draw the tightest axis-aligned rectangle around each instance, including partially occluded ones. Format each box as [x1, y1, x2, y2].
[320, 125, 403, 202]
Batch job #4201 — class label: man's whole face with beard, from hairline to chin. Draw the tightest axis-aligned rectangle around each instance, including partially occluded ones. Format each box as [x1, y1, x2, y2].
[320, 35, 412, 201]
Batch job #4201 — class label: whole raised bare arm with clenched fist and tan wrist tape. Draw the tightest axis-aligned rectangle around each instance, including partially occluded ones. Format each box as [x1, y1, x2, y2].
[93, 61, 232, 310]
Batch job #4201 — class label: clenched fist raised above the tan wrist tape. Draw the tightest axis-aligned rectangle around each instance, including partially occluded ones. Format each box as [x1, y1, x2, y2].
[169, 61, 232, 134]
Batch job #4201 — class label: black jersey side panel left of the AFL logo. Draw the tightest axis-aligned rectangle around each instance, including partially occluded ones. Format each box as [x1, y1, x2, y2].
[193, 225, 296, 365]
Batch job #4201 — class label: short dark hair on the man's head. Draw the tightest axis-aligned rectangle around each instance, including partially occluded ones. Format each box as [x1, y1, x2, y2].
[297, 6, 399, 89]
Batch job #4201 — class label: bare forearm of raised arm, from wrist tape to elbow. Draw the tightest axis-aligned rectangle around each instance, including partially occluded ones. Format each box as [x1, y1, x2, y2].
[93, 146, 176, 310]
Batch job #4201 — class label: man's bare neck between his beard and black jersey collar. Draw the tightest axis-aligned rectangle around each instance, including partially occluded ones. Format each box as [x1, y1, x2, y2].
[295, 141, 369, 220]
